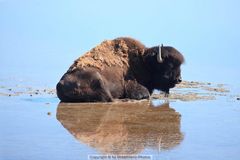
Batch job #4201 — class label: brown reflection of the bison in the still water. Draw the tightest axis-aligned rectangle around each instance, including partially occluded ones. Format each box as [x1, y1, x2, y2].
[57, 101, 183, 154]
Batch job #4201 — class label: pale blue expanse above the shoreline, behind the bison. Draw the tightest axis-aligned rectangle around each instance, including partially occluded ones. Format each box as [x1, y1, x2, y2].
[0, 0, 240, 84]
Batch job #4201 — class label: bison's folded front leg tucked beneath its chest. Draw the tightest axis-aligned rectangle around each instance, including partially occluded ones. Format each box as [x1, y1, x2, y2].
[125, 80, 150, 100]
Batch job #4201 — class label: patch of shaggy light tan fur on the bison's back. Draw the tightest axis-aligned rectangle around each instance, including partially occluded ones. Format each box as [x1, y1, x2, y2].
[71, 39, 137, 70]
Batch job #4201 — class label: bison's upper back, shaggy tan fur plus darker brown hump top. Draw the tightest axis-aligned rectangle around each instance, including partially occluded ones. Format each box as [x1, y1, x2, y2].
[69, 37, 145, 71]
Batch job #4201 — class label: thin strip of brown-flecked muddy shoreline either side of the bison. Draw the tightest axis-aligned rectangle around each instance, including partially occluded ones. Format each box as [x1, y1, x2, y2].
[0, 81, 240, 102]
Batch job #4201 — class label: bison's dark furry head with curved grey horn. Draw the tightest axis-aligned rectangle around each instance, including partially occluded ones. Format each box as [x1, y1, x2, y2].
[145, 45, 184, 93]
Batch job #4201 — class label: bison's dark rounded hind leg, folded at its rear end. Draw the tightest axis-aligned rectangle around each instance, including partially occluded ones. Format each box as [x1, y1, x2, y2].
[57, 70, 112, 102]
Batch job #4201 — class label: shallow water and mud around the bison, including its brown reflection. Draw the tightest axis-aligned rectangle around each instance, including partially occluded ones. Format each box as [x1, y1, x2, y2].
[0, 81, 240, 160]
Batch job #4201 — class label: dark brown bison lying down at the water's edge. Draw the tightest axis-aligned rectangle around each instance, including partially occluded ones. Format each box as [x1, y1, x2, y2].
[56, 38, 184, 102]
